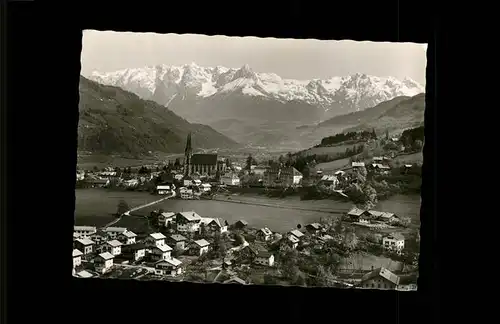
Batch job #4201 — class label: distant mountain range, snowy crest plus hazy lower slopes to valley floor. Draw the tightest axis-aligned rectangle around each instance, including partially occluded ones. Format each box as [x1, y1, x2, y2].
[89, 63, 425, 149]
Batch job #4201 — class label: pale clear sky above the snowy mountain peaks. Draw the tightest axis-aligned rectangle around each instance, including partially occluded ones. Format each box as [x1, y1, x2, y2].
[81, 30, 427, 85]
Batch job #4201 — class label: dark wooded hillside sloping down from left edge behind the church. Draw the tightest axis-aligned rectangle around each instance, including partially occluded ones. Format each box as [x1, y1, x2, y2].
[78, 77, 238, 155]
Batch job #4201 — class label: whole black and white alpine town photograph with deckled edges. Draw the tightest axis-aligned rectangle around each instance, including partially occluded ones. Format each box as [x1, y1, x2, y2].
[73, 30, 427, 291]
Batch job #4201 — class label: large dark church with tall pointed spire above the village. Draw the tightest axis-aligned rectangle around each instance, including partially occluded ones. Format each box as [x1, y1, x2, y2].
[184, 133, 226, 176]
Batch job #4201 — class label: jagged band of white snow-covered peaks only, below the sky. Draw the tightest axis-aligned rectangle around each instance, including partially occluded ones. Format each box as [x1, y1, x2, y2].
[90, 62, 425, 111]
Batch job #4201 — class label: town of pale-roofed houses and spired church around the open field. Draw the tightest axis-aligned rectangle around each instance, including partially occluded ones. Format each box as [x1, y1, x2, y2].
[73, 130, 420, 290]
